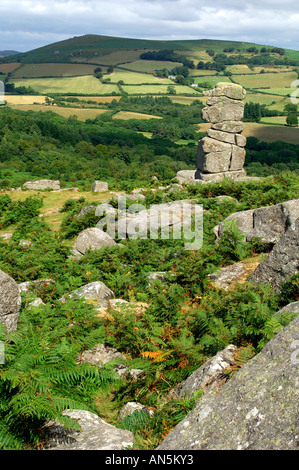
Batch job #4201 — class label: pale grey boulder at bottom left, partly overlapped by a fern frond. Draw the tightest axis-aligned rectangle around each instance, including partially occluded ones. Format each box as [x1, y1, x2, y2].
[43, 410, 135, 451]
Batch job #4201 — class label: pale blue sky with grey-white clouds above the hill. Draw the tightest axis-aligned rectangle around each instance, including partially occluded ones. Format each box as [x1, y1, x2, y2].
[0, 0, 299, 52]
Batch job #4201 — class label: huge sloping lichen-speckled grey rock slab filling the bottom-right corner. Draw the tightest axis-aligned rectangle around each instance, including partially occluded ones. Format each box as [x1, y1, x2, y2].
[157, 316, 299, 450]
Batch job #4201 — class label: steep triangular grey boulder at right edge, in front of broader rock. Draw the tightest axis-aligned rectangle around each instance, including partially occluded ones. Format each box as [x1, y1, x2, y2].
[249, 218, 299, 293]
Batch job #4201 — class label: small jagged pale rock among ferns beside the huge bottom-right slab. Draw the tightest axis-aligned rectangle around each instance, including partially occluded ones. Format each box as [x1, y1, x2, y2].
[168, 344, 237, 399]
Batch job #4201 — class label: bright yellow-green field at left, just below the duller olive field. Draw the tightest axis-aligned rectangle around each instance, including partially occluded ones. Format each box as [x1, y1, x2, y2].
[13, 75, 119, 95]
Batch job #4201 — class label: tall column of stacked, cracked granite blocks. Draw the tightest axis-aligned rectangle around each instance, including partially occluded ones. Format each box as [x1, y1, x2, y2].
[195, 82, 246, 181]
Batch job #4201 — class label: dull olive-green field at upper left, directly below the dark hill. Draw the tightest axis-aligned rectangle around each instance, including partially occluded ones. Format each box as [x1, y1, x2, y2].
[12, 63, 102, 78]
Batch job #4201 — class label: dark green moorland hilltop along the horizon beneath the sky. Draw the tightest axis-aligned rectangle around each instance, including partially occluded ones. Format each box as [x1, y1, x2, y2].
[0, 34, 299, 64]
